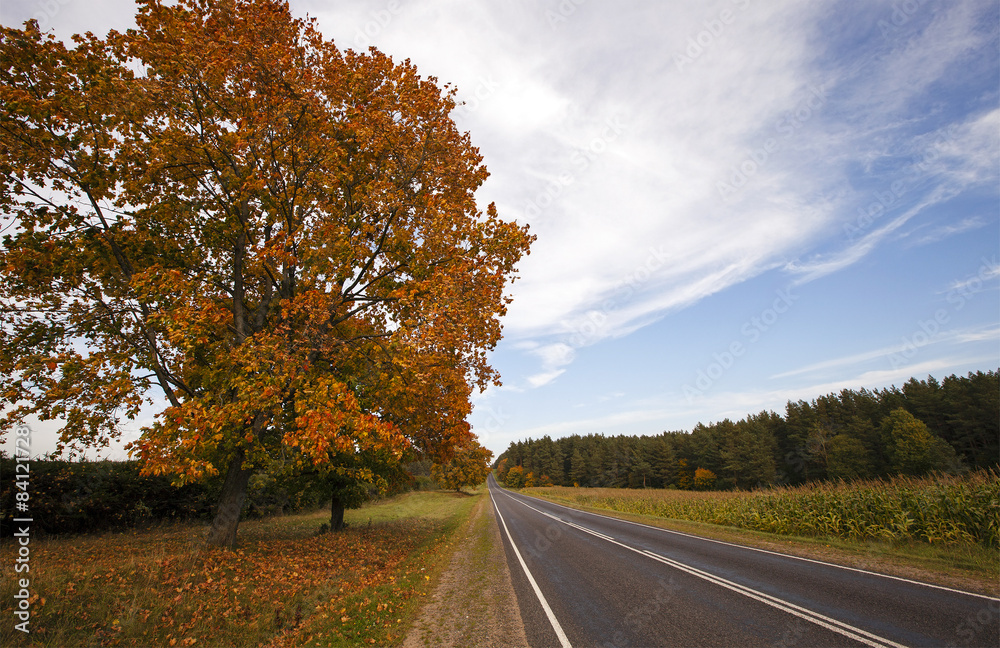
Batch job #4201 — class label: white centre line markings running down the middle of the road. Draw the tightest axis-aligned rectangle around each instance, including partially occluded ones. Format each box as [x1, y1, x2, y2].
[494, 497, 906, 648]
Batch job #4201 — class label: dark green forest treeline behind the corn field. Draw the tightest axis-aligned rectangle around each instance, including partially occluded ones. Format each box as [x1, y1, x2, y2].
[494, 371, 1000, 489]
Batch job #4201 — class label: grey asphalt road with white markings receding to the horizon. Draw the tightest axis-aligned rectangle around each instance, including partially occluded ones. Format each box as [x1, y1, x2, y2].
[489, 475, 1000, 648]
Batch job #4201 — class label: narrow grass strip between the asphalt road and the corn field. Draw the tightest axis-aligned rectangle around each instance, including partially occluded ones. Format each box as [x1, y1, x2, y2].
[521, 487, 1000, 596]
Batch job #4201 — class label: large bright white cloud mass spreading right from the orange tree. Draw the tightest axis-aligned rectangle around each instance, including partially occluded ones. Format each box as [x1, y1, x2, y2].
[290, 0, 992, 385]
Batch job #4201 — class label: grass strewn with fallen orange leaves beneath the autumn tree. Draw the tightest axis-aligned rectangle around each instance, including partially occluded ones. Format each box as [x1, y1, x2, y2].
[0, 492, 477, 647]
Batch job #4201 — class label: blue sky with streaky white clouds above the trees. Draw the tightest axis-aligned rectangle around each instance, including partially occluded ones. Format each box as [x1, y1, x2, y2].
[0, 0, 1000, 453]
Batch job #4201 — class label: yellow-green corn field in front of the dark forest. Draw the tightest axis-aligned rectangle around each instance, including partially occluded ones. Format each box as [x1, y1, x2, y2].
[535, 471, 1000, 547]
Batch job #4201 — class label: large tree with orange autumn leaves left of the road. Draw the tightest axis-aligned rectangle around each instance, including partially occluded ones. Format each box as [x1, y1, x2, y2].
[0, 0, 532, 545]
